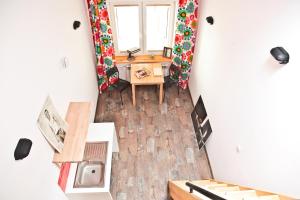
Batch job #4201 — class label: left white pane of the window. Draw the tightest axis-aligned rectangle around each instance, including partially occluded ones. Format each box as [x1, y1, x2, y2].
[115, 6, 140, 51]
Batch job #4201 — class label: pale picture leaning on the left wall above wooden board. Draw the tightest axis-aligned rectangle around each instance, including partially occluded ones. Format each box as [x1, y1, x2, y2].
[37, 96, 68, 152]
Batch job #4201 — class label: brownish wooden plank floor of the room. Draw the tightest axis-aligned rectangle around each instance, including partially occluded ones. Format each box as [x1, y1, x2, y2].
[95, 86, 211, 200]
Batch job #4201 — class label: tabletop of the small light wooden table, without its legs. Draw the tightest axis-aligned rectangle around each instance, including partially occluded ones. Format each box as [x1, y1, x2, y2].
[130, 63, 164, 85]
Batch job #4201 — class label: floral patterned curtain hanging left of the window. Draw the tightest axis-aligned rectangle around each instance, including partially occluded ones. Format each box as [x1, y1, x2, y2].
[87, 0, 117, 93]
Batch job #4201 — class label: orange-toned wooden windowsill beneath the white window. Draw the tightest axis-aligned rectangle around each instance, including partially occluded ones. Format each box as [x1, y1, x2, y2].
[115, 55, 172, 64]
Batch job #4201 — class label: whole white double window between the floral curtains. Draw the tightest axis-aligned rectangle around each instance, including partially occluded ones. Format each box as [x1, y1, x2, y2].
[109, 0, 176, 55]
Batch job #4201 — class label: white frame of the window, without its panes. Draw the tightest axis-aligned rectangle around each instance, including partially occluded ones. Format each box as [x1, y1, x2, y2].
[107, 0, 178, 56]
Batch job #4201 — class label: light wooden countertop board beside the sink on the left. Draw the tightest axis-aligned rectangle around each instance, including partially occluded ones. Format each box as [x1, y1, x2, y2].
[53, 102, 91, 163]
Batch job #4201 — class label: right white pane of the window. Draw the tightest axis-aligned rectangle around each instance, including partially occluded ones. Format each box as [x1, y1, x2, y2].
[146, 6, 170, 51]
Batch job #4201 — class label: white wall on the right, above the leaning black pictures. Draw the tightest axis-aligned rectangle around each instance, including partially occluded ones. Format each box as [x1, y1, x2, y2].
[190, 0, 300, 198]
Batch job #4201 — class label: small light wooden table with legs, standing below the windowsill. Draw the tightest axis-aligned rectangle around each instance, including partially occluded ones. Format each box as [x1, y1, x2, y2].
[130, 63, 164, 106]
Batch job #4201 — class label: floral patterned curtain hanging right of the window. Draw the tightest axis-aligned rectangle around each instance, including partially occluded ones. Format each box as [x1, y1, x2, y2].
[172, 0, 198, 89]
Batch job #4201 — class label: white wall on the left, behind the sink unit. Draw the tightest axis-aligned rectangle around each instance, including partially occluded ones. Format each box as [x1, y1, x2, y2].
[0, 0, 98, 200]
